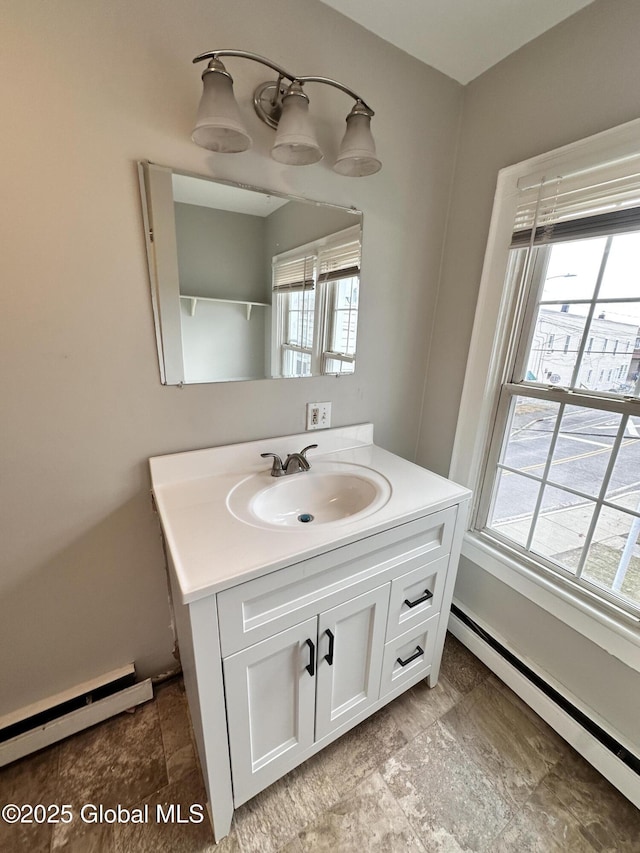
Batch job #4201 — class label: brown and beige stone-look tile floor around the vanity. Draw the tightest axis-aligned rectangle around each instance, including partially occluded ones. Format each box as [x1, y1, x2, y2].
[0, 636, 640, 853]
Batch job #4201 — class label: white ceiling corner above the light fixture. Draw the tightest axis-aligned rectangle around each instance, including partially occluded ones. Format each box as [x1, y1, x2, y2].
[323, 0, 593, 83]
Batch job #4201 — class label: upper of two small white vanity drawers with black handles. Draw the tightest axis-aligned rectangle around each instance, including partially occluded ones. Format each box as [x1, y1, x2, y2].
[387, 555, 449, 640]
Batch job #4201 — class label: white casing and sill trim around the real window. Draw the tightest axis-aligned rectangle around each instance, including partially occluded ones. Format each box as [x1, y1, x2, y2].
[449, 119, 640, 671]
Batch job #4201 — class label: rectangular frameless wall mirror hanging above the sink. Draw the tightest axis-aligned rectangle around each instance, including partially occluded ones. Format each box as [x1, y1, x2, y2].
[138, 162, 362, 385]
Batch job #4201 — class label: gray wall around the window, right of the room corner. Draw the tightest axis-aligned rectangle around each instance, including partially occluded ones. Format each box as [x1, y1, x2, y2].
[418, 0, 640, 743]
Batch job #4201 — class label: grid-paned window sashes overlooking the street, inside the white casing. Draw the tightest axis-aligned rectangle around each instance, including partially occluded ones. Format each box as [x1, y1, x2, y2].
[475, 176, 640, 616]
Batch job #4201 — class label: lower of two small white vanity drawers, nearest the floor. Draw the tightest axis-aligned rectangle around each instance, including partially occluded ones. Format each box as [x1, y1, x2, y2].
[380, 613, 439, 699]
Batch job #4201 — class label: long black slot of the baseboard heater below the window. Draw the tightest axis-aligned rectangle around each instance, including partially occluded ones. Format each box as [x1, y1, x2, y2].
[451, 604, 640, 776]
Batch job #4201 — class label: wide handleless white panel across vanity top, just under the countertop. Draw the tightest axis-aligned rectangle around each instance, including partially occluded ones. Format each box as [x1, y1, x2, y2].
[217, 507, 456, 657]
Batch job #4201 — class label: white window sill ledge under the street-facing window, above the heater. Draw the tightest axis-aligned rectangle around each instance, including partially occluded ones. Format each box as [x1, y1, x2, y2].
[462, 531, 640, 672]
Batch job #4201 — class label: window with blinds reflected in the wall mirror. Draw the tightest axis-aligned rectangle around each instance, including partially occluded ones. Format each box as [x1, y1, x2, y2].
[272, 227, 360, 377]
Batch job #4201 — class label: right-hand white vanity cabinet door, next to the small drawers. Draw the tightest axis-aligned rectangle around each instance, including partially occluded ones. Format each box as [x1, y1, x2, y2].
[316, 584, 390, 740]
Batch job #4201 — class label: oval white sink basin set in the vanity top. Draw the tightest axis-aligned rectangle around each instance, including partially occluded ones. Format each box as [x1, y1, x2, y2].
[227, 462, 391, 530]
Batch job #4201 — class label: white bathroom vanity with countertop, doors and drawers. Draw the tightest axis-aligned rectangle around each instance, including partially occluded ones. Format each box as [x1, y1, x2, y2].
[150, 424, 470, 840]
